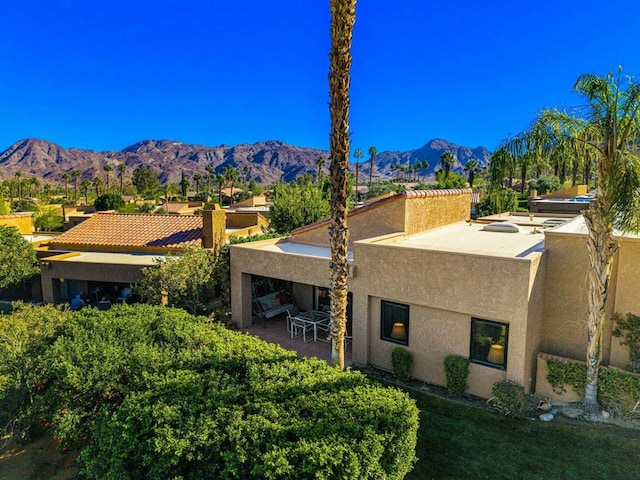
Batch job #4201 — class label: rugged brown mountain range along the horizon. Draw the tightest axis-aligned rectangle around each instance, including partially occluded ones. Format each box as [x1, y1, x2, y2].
[0, 138, 491, 184]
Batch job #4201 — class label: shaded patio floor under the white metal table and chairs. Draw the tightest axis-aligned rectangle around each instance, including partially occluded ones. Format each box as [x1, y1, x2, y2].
[242, 313, 351, 366]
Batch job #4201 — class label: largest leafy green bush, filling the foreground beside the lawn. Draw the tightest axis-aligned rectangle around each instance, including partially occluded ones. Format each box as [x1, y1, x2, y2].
[38, 305, 418, 479]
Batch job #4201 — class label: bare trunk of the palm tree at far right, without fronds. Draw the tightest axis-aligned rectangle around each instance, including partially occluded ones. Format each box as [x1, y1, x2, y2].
[584, 198, 618, 412]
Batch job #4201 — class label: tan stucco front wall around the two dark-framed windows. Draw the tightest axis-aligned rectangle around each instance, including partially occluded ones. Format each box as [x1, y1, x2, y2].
[351, 242, 542, 397]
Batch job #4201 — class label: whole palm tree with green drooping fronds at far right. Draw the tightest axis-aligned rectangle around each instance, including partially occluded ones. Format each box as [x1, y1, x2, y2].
[516, 69, 640, 411]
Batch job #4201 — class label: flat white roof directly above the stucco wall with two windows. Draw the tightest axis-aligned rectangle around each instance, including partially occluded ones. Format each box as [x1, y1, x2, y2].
[388, 222, 544, 258]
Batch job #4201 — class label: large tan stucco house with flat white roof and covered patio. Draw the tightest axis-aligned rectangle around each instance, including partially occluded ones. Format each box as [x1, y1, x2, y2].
[231, 190, 640, 397]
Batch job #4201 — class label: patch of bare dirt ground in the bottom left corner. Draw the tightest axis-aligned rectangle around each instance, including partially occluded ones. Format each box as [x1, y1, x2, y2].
[0, 436, 78, 480]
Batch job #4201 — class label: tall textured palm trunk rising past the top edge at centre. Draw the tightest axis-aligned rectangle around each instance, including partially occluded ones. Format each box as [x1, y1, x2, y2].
[329, 0, 358, 370]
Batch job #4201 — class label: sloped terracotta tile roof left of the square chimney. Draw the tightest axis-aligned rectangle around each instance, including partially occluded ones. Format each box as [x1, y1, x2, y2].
[50, 213, 202, 249]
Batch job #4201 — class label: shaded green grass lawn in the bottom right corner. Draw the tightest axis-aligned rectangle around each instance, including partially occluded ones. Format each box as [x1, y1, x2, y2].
[406, 390, 640, 480]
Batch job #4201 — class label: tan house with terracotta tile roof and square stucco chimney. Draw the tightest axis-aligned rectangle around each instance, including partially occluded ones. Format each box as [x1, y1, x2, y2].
[39, 205, 267, 303]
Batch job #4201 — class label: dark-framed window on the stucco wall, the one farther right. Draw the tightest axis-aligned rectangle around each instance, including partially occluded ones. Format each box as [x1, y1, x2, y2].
[469, 318, 509, 370]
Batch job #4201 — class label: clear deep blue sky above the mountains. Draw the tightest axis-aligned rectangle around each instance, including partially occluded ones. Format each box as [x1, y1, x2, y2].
[0, 0, 640, 151]
